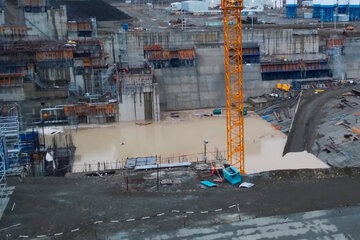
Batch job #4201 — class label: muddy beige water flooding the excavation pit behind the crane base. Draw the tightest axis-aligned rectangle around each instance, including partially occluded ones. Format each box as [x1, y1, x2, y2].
[73, 113, 327, 173]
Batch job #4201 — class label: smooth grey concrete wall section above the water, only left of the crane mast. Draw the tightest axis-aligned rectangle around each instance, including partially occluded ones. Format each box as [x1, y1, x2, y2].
[154, 44, 225, 110]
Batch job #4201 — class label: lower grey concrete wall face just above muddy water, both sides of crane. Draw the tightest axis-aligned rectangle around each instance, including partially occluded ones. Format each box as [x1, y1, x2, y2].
[154, 47, 290, 111]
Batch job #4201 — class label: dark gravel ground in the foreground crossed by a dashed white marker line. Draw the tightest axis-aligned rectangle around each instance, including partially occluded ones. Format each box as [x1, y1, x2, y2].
[0, 167, 360, 239]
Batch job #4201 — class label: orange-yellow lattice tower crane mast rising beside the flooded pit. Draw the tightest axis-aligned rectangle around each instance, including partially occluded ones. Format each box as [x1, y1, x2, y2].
[221, 0, 245, 174]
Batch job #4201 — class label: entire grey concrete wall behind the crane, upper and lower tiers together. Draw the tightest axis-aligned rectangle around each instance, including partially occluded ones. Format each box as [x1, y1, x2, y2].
[123, 28, 323, 110]
